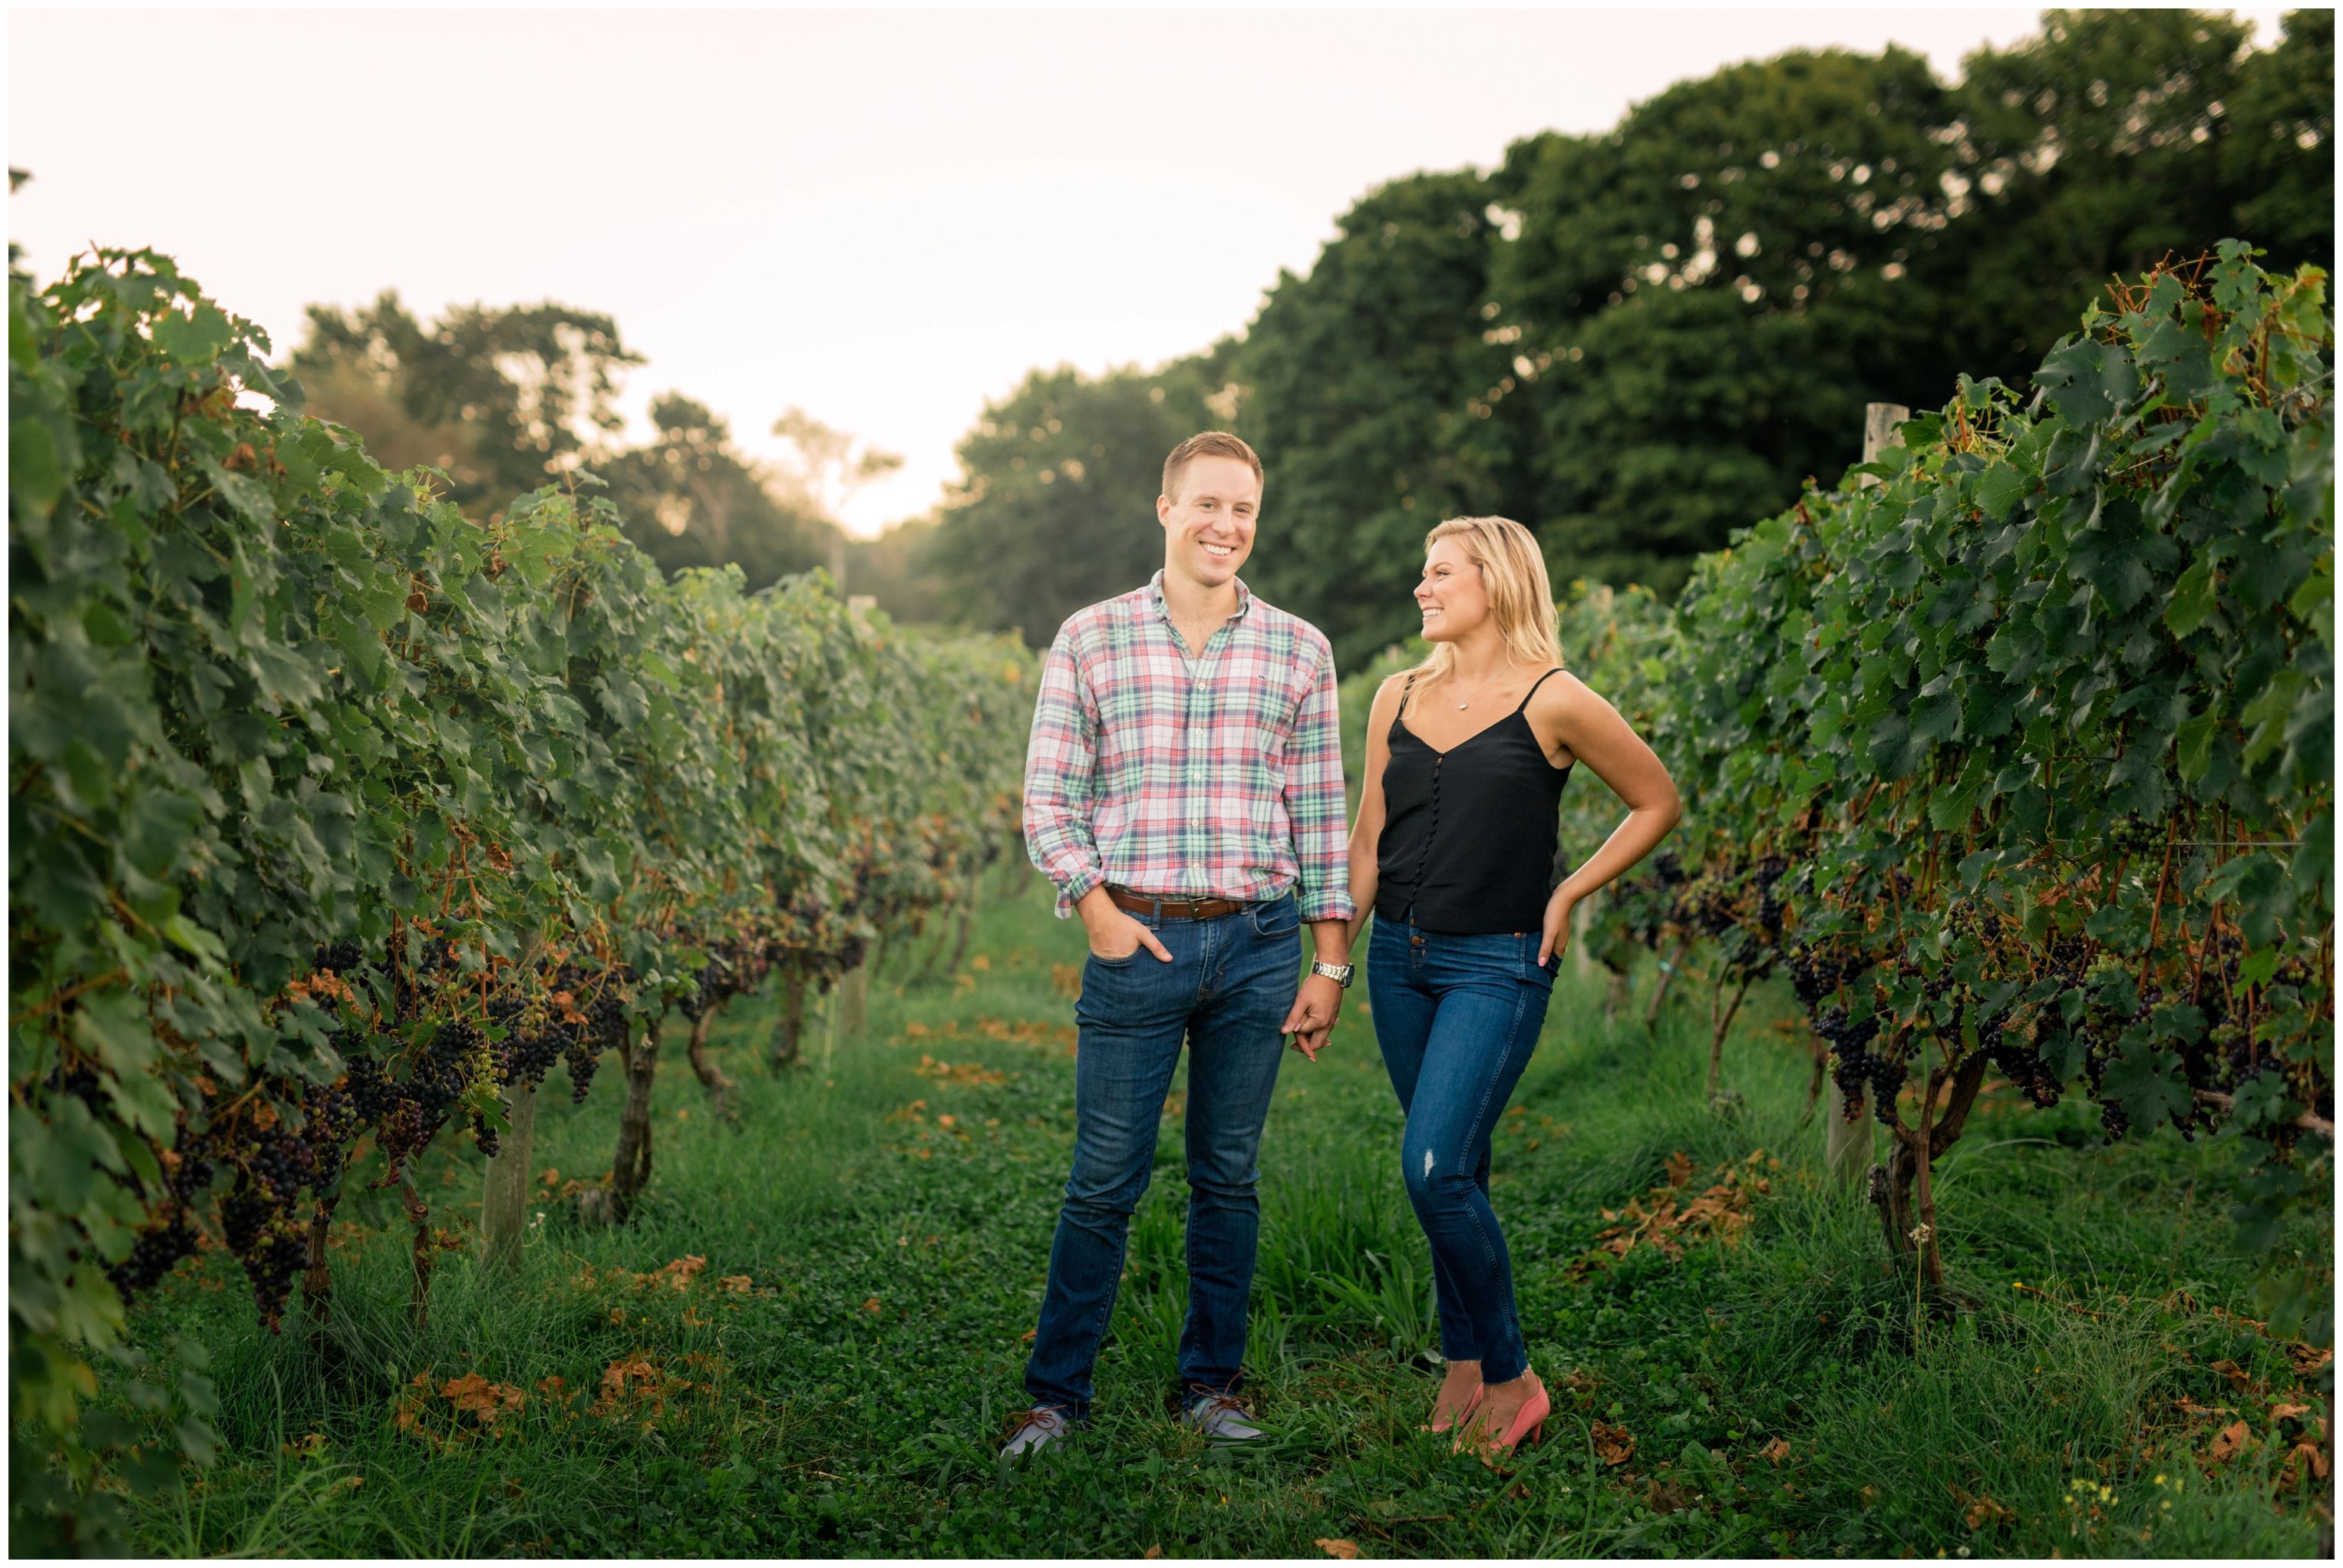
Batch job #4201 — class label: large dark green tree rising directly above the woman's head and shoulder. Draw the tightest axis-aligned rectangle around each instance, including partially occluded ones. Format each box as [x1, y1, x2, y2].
[1490, 47, 1963, 591]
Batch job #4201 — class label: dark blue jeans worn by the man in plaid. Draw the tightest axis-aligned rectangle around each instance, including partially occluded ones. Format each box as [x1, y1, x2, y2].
[1026, 896, 1300, 1421]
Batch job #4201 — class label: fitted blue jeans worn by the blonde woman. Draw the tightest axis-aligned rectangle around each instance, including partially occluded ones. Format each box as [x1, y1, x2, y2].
[1366, 919, 1558, 1383]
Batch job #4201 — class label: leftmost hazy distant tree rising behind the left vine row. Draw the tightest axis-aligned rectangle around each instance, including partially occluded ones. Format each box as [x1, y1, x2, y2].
[291, 291, 642, 507]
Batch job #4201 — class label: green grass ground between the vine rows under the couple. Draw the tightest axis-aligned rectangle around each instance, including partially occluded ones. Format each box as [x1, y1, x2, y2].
[105, 881, 2331, 1556]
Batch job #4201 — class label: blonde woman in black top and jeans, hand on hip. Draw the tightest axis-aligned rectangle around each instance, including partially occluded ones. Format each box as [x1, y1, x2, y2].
[1350, 518, 1682, 1448]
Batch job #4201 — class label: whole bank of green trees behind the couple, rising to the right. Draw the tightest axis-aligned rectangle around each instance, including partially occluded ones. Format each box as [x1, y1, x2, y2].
[923, 9, 2334, 661]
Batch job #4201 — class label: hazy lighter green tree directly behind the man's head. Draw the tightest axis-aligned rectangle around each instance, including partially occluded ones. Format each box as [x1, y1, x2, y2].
[912, 342, 1246, 647]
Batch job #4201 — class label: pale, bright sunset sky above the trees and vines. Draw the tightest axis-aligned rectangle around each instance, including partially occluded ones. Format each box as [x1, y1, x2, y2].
[7, 5, 2280, 534]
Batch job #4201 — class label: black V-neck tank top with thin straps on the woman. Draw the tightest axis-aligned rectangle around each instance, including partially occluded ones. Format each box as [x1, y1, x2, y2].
[1375, 670, 1570, 935]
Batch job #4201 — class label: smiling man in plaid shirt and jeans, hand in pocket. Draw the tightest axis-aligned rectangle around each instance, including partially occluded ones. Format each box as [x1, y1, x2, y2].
[1005, 431, 1352, 1455]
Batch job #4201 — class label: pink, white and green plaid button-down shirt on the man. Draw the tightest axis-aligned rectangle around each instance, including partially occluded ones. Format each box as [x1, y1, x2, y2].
[1024, 572, 1352, 921]
